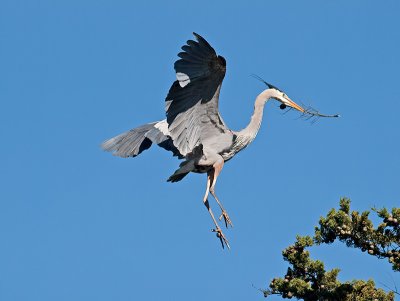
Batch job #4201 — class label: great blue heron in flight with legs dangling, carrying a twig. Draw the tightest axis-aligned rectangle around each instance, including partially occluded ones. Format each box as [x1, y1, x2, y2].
[102, 33, 316, 248]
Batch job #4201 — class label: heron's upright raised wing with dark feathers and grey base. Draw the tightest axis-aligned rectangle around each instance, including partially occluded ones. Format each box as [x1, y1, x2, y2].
[166, 33, 231, 156]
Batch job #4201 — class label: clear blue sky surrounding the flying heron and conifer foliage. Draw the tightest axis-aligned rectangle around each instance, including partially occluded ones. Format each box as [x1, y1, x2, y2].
[0, 0, 400, 301]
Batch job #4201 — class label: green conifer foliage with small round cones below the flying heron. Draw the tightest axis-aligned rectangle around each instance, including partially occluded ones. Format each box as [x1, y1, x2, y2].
[263, 198, 400, 301]
